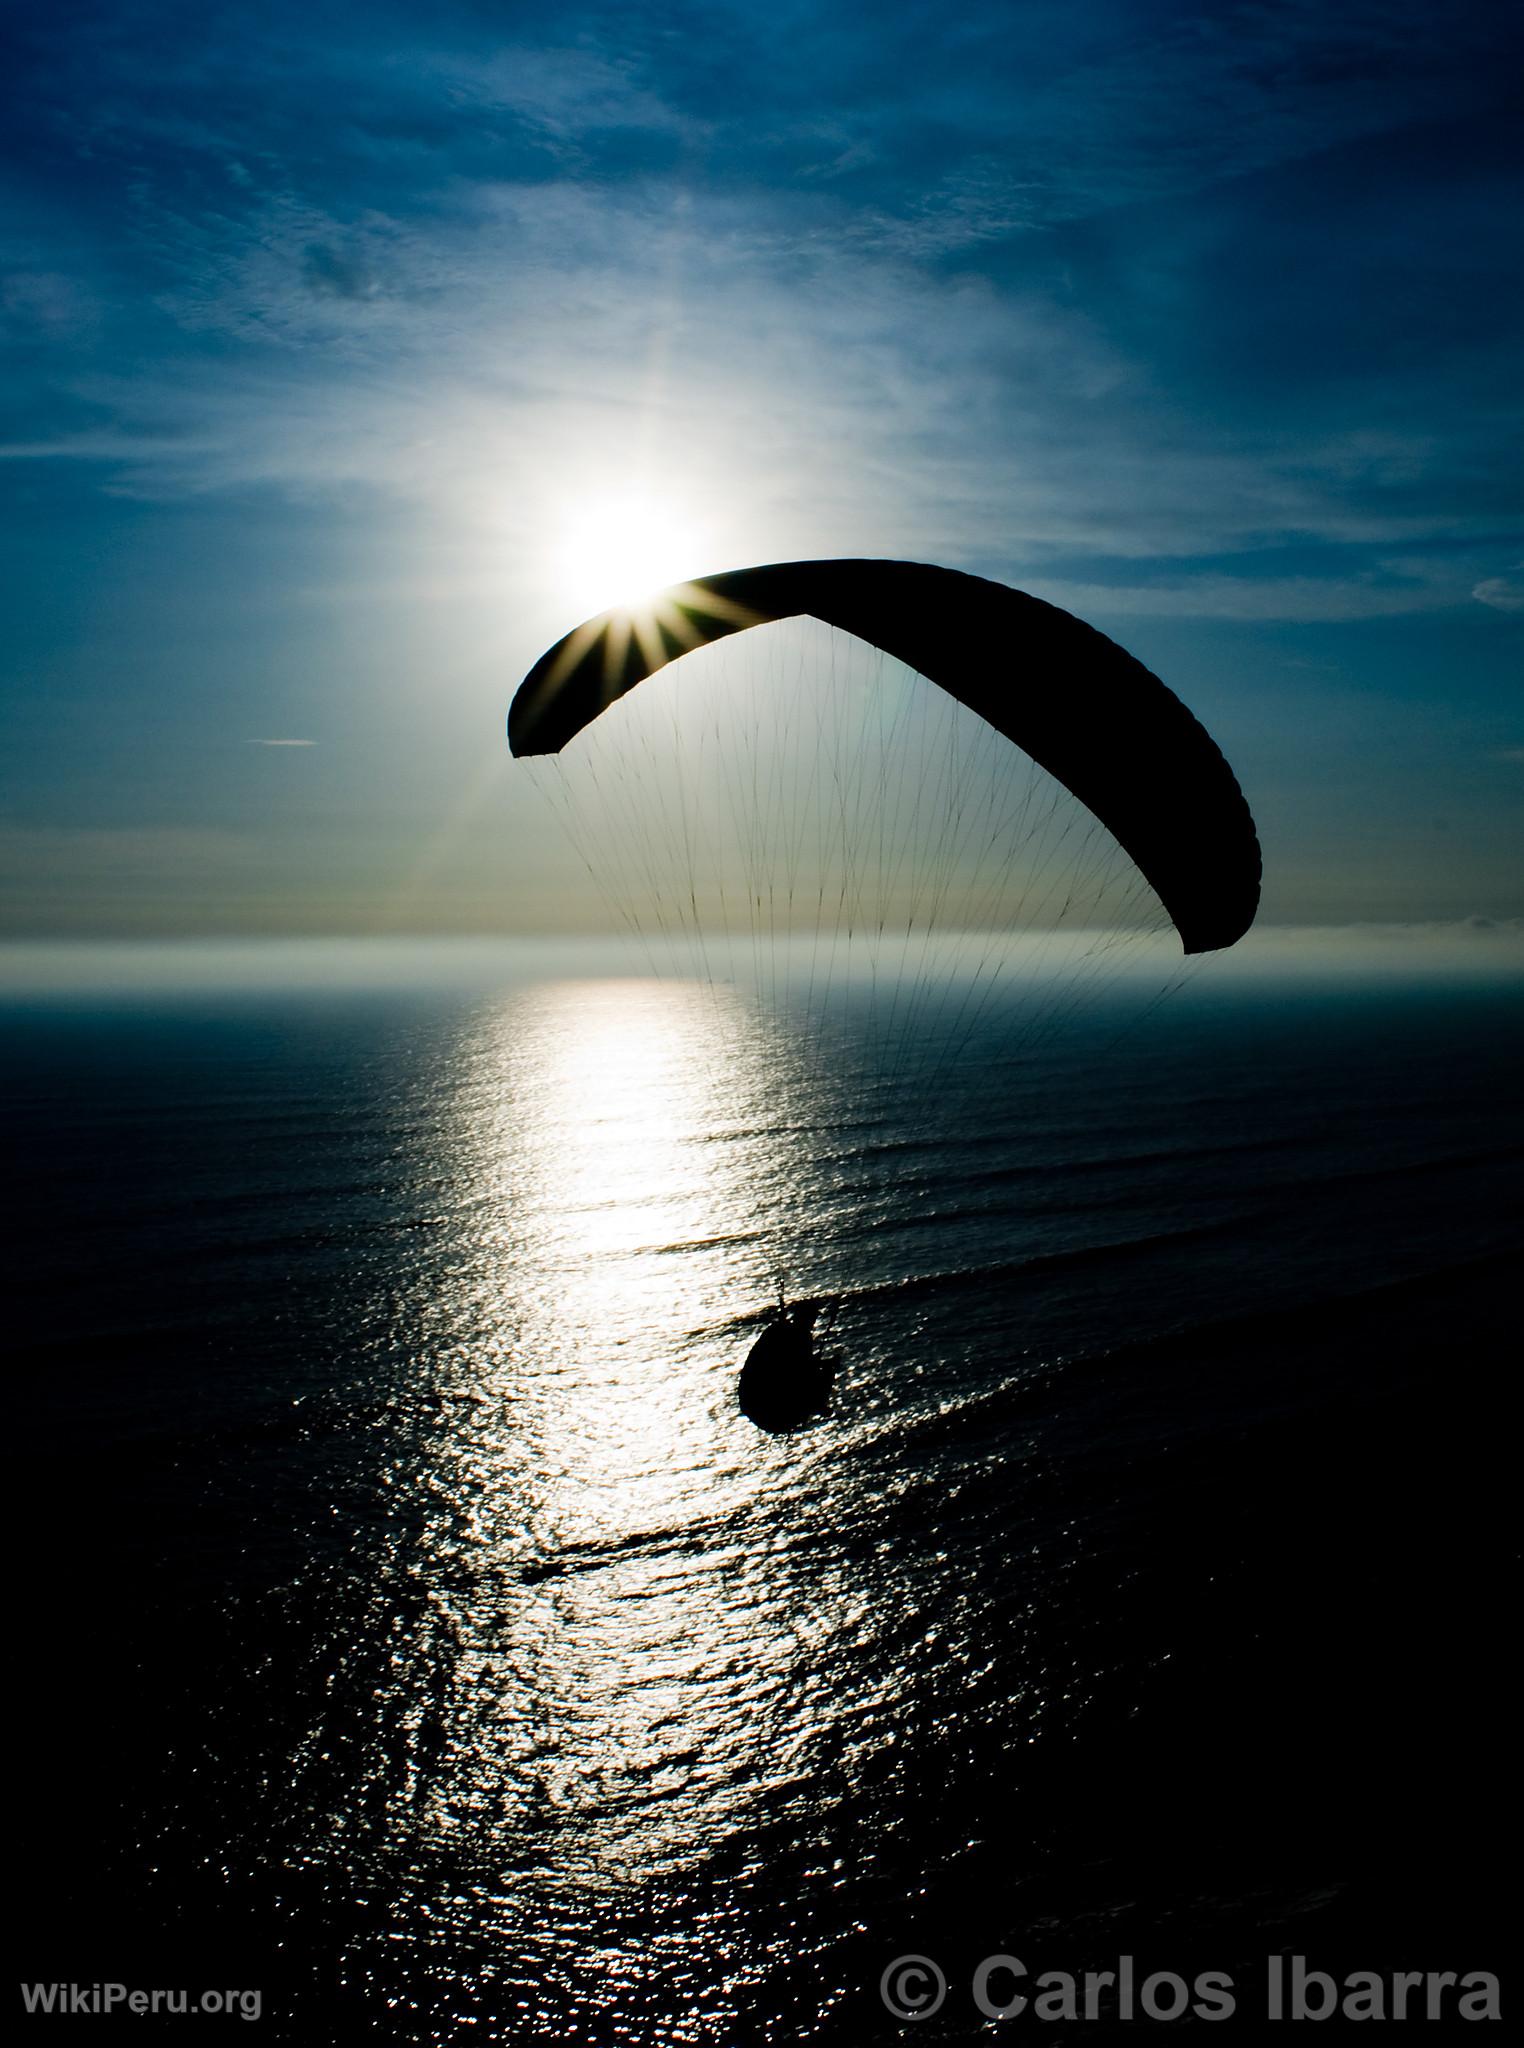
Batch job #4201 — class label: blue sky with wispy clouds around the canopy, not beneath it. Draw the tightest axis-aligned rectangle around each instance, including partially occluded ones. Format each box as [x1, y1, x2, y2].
[0, 0, 1524, 936]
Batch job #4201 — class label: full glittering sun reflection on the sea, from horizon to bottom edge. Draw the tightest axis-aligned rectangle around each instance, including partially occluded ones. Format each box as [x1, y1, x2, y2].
[268, 983, 1056, 2048]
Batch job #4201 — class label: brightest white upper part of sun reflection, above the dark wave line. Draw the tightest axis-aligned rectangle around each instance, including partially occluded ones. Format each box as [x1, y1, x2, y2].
[477, 983, 787, 1544]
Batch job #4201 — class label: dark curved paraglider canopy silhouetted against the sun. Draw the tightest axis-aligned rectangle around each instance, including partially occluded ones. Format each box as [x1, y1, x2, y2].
[508, 559, 1260, 952]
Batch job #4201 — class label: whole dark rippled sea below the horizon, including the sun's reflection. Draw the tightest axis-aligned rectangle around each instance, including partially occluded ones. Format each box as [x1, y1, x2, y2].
[0, 983, 1524, 2044]
